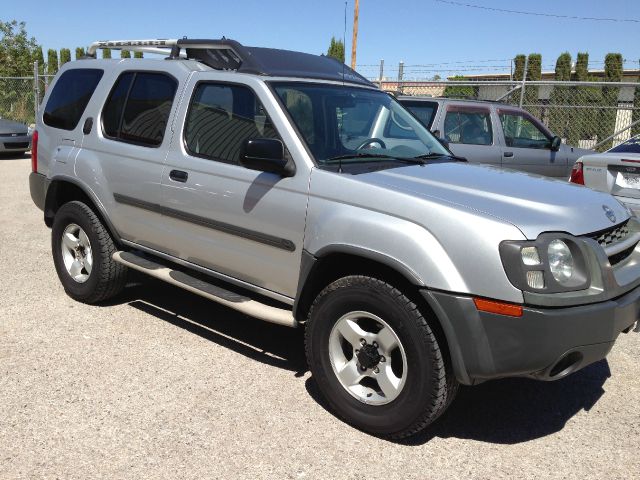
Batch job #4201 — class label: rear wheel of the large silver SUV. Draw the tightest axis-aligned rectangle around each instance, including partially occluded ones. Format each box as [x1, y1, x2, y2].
[51, 201, 127, 304]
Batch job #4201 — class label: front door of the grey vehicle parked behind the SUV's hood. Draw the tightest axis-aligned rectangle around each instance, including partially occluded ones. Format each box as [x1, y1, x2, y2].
[498, 108, 567, 179]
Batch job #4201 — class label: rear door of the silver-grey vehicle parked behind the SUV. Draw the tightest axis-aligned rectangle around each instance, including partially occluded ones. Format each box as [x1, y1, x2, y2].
[440, 103, 501, 165]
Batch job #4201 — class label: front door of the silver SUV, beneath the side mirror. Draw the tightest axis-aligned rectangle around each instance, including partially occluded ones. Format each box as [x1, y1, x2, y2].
[162, 74, 310, 298]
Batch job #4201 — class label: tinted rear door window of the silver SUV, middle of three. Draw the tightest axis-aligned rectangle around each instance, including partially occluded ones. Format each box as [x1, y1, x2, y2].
[102, 72, 178, 147]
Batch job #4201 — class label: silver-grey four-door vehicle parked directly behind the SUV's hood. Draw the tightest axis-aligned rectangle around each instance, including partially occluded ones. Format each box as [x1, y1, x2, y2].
[398, 97, 594, 179]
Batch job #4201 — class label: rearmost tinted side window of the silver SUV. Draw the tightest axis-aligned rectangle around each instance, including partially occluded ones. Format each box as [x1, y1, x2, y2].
[43, 68, 103, 130]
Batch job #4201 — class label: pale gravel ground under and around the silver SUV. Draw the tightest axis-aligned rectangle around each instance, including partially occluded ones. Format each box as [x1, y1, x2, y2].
[0, 157, 640, 480]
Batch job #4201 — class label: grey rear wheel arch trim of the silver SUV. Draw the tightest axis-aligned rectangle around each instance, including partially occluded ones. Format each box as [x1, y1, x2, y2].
[44, 177, 121, 246]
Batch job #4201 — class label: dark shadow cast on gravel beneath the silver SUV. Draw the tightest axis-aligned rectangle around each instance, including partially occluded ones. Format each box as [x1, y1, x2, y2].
[110, 272, 611, 445]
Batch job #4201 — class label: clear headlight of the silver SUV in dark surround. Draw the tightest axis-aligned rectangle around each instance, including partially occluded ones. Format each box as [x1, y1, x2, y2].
[500, 233, 591, 293]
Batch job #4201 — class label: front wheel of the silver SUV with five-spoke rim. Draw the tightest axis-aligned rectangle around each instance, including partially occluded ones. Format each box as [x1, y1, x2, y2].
[305, 276, 458, 439]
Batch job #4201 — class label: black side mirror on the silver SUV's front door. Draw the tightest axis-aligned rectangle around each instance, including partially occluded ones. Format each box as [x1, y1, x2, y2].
[240, 138, 295, 177]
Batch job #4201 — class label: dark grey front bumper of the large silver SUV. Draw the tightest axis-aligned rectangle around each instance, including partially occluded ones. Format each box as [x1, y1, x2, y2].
[423, 287, 640, 385]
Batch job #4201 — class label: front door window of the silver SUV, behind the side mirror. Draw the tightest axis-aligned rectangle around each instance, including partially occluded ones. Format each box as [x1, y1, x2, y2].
[184, 83, 280, 164]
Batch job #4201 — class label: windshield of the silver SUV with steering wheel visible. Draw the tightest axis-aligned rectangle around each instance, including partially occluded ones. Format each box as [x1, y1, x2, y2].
[274, 82, 450, 167]
